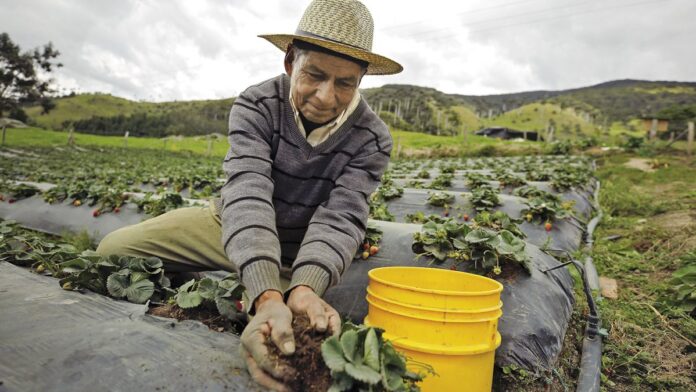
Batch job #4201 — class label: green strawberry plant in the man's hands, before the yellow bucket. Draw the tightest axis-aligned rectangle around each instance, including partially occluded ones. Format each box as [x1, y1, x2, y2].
[321, 323, 434, 392]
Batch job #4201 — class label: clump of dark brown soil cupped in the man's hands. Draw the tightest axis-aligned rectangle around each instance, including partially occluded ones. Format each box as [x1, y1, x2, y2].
[266, 316, 332, 392]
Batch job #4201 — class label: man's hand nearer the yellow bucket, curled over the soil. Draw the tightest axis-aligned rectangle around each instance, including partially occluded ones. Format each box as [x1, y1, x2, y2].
[288, 286, 341, 335]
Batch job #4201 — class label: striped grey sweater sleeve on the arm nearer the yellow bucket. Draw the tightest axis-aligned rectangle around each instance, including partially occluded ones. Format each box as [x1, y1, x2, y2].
[286, 127, 392, 296]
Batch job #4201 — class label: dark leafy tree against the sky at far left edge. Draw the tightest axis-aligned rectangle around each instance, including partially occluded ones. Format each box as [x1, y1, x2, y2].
[0, 33, 63, 117]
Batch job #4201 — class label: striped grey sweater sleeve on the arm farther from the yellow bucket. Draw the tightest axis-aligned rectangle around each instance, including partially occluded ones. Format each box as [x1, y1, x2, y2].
[220, 92, 282, 312]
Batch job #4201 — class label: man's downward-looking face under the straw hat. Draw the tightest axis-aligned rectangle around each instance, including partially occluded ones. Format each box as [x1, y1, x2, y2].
[286, 51, 362, 124]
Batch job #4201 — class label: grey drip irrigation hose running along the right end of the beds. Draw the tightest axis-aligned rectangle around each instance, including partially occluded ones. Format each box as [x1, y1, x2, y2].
[542, 175, 603, 392]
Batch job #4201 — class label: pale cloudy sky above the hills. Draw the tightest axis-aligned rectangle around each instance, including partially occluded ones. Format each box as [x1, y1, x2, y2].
[0, 0, 696, 101]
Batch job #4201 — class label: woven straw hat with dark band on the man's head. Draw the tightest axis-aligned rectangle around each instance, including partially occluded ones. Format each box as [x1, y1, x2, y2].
[259, 0, 403, 75]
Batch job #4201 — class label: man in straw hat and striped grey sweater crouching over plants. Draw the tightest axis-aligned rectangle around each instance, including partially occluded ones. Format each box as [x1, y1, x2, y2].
[97, 0, 402, 390]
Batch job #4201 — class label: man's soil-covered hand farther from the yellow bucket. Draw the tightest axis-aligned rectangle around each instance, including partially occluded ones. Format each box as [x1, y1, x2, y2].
[240, 290, 295, 392]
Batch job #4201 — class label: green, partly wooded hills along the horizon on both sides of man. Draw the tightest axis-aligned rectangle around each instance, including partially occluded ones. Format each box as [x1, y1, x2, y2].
[21, 79, 696, 138]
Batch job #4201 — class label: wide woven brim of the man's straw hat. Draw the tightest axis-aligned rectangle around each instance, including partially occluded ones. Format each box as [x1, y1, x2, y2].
[259, 34, 404, 75]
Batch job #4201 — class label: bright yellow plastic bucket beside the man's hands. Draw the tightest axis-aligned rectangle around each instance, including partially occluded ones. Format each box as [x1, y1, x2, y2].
[365, 267, 503, 392]
